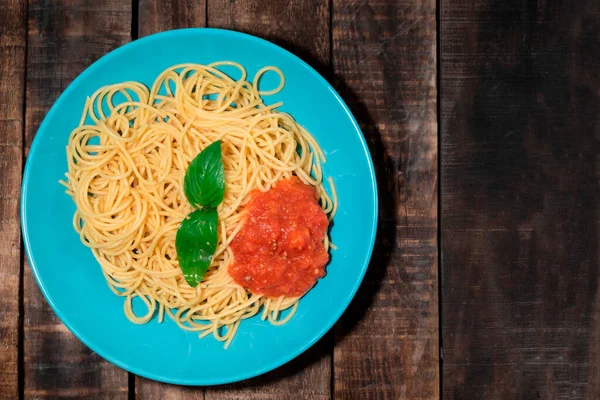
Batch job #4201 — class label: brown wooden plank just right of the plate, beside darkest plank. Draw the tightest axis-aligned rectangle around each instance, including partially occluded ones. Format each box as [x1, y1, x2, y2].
[332, 0, 439, 399]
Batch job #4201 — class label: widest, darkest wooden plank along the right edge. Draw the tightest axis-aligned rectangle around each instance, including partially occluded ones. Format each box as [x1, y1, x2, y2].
[441, 0, 600, 399]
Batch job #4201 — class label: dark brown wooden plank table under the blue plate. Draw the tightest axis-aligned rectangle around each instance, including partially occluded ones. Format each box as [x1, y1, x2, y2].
[0, 0, 600, 400]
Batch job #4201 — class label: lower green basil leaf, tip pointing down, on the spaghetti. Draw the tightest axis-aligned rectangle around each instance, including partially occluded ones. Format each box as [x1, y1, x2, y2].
[175, 208, 218, 287]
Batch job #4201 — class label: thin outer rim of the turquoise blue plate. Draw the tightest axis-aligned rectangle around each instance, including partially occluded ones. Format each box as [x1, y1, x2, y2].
[19, 28, 379, 386]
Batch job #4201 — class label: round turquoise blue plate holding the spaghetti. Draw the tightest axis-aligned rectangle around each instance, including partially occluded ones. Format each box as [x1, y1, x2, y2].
[21, 29, 377, 385]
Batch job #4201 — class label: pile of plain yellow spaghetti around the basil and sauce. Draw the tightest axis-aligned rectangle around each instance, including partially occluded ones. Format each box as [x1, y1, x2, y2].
[61, 62, 337, 347]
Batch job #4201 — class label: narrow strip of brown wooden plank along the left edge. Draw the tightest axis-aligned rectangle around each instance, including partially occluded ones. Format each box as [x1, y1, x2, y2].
[0, 0, 27, 399]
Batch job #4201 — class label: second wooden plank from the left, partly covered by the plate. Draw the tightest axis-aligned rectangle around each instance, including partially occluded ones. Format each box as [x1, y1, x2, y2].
[24, 0, 131, 399]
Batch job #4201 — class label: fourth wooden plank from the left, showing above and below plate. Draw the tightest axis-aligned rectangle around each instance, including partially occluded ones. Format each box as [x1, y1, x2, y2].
[206, 0, 332, 400]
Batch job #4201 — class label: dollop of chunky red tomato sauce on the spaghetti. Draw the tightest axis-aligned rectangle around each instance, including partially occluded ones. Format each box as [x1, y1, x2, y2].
[229, 177, 329, 297]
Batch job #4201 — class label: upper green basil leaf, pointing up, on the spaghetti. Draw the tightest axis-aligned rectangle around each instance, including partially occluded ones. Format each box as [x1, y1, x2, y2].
[183, 140, 225, 208]
